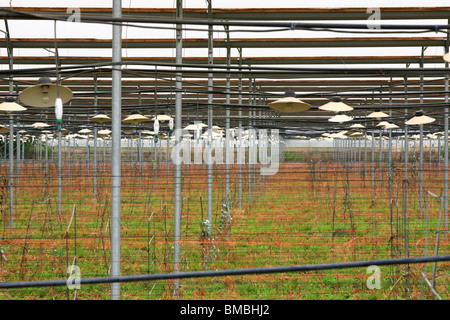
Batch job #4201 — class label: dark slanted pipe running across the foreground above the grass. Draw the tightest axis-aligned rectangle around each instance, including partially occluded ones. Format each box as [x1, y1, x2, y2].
[0, 255, 450, 289]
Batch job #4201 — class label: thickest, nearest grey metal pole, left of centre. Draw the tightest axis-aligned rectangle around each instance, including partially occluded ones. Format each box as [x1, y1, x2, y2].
[111, 0, 122, 300]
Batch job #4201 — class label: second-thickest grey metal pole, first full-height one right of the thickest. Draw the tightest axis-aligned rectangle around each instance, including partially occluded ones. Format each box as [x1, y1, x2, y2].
[172, 0, 183, 298]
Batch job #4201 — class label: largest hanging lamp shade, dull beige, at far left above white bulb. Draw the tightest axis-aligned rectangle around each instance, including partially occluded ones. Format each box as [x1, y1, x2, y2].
[19, 77, 73, 108]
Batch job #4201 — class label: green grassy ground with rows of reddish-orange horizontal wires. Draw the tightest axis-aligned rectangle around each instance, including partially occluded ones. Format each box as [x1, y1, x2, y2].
[0, 139, 450, 299]
